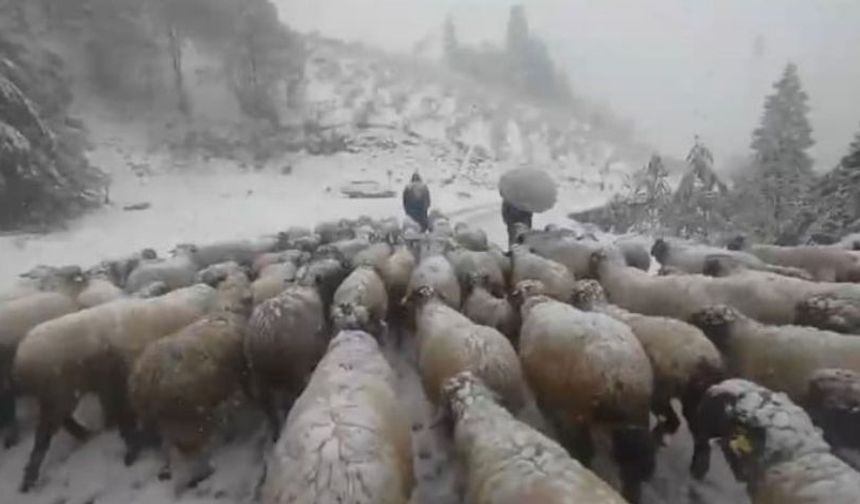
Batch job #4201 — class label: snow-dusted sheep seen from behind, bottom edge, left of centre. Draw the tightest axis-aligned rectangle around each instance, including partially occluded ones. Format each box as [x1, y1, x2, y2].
[261, 331, 415, 504]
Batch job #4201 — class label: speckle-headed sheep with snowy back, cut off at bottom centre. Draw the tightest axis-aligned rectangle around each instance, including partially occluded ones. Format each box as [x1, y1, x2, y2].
[443, 372, 626, 504]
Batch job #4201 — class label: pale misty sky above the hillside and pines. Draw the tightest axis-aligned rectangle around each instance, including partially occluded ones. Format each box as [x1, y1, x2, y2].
[276, 0, 860, 169]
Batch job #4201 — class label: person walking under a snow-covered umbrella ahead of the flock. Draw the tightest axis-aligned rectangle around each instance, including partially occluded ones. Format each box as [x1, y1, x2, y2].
[499, 168, 558, 245]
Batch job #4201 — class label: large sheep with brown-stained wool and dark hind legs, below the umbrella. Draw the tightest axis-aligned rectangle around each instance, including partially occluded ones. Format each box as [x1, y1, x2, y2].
[519, 293, 655, 502]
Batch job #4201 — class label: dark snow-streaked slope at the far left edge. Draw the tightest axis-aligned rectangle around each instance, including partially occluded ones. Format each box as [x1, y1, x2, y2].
[0, 0, 102, 229]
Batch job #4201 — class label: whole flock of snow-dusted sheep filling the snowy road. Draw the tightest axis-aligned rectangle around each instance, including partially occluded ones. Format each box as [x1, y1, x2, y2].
[0, 208, 860, 504]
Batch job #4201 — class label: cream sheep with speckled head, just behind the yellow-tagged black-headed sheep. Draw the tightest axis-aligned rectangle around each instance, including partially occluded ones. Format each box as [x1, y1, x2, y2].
[690, 305, 860, 403]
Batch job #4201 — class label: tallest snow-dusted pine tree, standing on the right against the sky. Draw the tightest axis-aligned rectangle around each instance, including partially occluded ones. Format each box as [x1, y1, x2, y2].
[751, 63, 815, 233]
